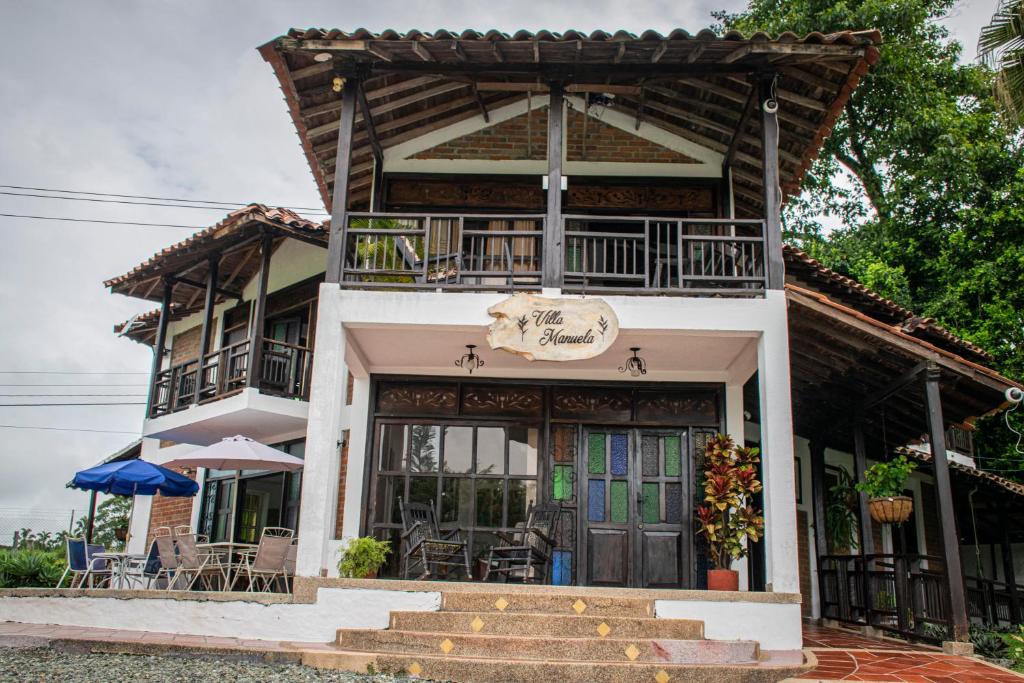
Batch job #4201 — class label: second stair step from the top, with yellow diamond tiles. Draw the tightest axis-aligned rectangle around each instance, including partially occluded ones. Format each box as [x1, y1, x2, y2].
[389, 611, 703, 640]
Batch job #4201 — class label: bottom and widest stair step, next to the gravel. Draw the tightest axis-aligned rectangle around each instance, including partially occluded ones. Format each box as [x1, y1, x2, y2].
[302, 648, 813, 683]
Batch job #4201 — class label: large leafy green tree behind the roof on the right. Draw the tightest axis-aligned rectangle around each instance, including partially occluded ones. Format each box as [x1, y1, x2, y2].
[718, 0, 1024, 474]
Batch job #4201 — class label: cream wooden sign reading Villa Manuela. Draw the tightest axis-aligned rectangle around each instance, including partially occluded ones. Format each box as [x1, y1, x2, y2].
[487, 294, 618, 360]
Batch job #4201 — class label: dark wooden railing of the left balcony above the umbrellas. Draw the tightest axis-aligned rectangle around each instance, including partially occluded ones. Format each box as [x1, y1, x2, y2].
[150, 339, 312, 418]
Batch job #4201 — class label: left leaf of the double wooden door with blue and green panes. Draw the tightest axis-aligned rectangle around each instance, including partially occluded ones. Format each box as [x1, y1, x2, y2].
[580, 428, 637, 587]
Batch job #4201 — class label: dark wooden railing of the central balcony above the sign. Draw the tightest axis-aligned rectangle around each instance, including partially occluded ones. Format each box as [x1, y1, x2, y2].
[340, 213, 767, 297]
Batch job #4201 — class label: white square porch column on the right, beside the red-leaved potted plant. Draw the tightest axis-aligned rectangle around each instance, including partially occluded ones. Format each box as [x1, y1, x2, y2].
[758, 290, 800, 593]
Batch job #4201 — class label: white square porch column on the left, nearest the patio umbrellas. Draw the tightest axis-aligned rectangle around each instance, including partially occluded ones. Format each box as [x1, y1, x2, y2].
[295, 284, 347, 577]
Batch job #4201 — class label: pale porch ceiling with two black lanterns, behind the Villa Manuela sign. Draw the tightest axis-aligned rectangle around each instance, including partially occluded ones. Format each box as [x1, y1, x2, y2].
[346, 326, 756, 381]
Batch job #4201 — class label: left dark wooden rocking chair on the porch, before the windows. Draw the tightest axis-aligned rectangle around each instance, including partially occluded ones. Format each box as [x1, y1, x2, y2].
[398, 498, 473, 581]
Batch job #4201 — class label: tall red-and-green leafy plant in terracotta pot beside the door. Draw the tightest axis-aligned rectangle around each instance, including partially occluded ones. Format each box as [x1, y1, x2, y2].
[697, 434, 765, 591]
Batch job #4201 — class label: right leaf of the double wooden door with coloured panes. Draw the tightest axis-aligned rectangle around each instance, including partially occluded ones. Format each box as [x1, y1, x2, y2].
[633, 429, 693, 588]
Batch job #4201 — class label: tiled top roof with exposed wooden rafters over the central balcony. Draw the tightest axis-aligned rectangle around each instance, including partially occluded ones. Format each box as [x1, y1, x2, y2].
[259, 29, 881, 217]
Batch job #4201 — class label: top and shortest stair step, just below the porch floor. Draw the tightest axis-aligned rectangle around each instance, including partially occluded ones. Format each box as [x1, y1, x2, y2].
[441, 592, 654, 616]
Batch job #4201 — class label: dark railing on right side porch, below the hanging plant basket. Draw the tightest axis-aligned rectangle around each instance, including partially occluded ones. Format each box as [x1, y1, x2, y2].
[818, 554, 949, 642]
